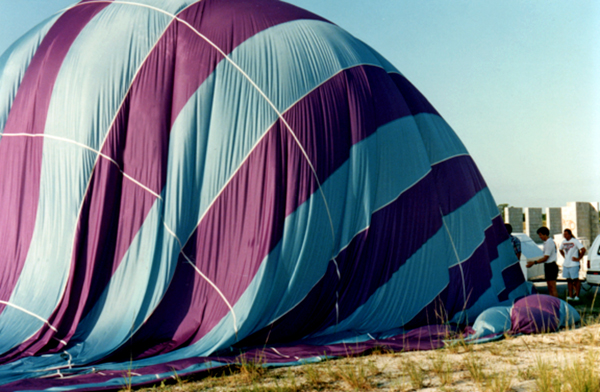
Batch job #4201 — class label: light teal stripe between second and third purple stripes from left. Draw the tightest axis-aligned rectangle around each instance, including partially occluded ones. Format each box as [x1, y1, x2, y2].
[67, 17, 390, 361]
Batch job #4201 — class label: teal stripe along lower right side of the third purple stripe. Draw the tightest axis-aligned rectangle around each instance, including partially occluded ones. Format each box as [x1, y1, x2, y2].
[148, 117, 430, 359]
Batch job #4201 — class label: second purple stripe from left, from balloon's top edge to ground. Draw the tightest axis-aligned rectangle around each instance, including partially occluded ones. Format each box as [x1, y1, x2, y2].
[25, 1, 328, 351]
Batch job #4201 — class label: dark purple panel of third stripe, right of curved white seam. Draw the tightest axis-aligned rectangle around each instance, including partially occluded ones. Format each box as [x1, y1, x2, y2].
[284, 66, 411, 207]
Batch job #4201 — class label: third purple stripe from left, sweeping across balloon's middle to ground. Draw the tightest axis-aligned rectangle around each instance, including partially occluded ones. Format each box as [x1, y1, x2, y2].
[108, 66, 422, 357]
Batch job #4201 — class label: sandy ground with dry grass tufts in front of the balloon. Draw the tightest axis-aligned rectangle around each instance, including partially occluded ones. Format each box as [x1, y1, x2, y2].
[138, 283, 600, 392]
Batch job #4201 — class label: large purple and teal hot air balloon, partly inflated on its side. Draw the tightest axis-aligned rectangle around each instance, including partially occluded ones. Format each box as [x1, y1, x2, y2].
[0, 0, 530, 390]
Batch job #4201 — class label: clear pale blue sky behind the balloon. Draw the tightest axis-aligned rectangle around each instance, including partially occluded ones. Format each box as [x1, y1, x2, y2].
[0, 0, 600, 207]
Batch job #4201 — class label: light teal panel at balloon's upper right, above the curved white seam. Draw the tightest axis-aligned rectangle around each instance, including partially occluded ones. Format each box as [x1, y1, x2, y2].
[225, 20, 382, 112]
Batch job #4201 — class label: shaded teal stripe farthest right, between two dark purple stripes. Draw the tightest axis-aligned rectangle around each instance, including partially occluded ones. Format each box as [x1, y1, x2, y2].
[313, 188, 505, 337]
